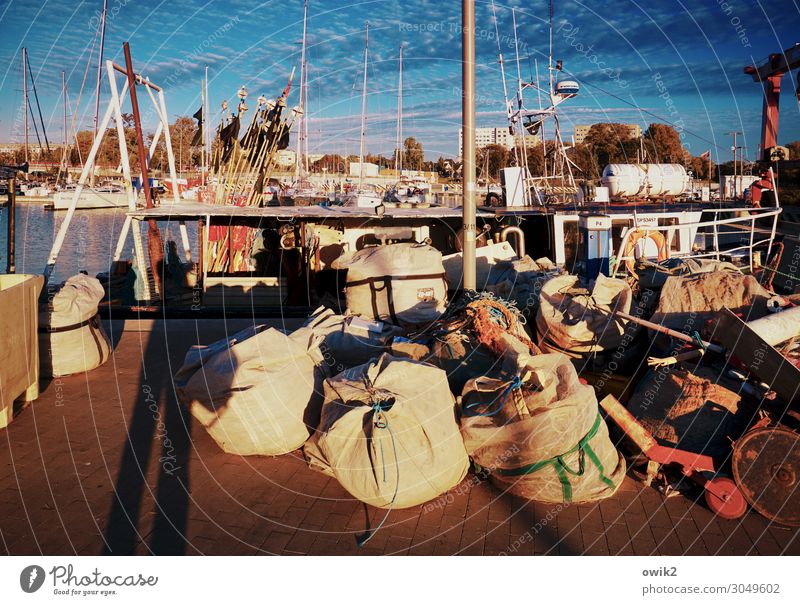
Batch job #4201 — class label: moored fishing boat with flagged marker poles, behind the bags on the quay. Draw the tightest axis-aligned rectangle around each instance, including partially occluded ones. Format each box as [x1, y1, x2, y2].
[42, 10, 780, 309]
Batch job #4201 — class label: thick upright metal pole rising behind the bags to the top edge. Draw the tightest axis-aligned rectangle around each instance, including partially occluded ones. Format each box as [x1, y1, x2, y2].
[461, 0, 477, 290]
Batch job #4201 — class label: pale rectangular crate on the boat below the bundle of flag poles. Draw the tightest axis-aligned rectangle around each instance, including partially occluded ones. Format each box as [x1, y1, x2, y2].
[203, 276, 287, 307]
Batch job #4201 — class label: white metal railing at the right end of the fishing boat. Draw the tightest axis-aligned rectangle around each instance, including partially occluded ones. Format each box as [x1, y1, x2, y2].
[611, 207, 783, 277]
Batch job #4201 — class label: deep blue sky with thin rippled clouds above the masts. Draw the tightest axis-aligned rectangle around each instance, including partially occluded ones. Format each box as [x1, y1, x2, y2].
[0, 0, 800, 161]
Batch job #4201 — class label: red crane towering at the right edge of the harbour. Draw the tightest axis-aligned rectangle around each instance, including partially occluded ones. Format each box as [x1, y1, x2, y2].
[744, 42, 800, 162]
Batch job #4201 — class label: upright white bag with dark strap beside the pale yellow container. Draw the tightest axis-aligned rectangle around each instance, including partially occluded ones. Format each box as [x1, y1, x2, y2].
[39, 273, 111, 376]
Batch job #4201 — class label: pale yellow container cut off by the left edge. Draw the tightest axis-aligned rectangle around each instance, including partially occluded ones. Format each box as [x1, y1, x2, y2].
[0, 275, 44, 428]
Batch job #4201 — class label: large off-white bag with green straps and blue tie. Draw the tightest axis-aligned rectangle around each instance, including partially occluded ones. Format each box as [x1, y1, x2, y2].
[461, 346, 625, 503]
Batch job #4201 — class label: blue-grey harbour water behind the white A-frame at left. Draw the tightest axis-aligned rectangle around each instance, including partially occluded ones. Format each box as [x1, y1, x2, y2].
[0, 202, 197, 283]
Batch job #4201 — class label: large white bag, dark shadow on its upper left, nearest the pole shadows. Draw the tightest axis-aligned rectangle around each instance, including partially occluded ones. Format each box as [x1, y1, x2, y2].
[175, 326, 325, 456]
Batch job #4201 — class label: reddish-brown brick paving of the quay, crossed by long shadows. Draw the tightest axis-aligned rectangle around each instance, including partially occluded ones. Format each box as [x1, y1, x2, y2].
[0, 320, 800, 555]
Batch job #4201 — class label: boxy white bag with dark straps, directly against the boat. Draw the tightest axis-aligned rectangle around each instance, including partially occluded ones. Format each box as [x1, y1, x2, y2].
[334, 243, 447, 325]
